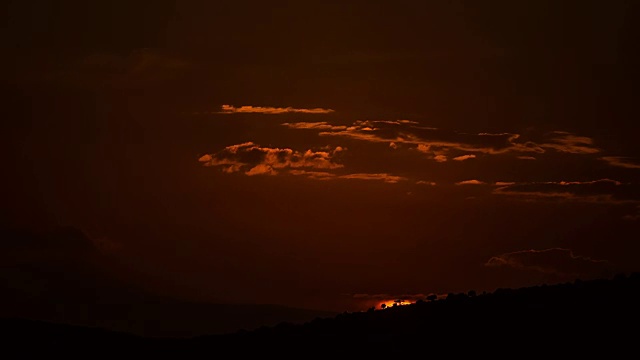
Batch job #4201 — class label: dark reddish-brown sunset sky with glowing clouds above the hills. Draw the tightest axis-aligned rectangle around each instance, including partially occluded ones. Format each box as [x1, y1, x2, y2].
[0, 0, 640, 311]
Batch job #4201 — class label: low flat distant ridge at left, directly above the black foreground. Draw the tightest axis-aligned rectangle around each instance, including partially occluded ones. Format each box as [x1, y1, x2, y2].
[0, 299, 336, 338]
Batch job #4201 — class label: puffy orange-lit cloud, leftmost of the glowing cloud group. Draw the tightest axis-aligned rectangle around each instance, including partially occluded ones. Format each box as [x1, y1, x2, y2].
[198, 142, 344, 176]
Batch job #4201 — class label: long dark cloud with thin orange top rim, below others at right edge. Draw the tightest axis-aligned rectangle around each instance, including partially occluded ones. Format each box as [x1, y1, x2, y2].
[493, 179, 640, 204]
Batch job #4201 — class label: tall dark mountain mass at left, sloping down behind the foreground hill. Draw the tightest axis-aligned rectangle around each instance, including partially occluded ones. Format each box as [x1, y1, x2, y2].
[0, 227, 335, 337]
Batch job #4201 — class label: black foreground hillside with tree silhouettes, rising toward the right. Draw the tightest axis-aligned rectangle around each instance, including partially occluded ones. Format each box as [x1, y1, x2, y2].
[0, 273, 640, 359]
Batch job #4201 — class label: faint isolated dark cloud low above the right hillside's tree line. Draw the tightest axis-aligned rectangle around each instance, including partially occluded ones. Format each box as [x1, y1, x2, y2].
[485, 248, 611, 278]
